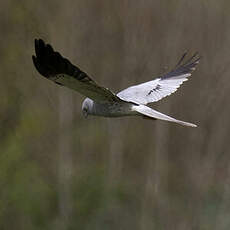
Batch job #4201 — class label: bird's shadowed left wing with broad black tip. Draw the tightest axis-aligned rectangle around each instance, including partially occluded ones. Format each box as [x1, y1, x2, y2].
[32, 39, 121, 102]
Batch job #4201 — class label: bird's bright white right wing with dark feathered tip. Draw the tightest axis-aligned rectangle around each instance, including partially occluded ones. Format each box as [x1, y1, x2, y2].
[117, 53, 200, 105]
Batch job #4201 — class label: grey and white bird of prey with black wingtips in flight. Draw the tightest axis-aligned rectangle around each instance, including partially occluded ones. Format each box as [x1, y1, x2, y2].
[32, 39, 200, 127]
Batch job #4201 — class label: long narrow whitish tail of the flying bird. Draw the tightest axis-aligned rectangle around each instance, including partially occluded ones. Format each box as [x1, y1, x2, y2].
[133, 105, 197, 127]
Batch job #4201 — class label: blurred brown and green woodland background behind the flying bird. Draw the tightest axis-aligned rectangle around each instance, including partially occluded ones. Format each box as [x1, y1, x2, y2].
[0, 0, 230, 230]
